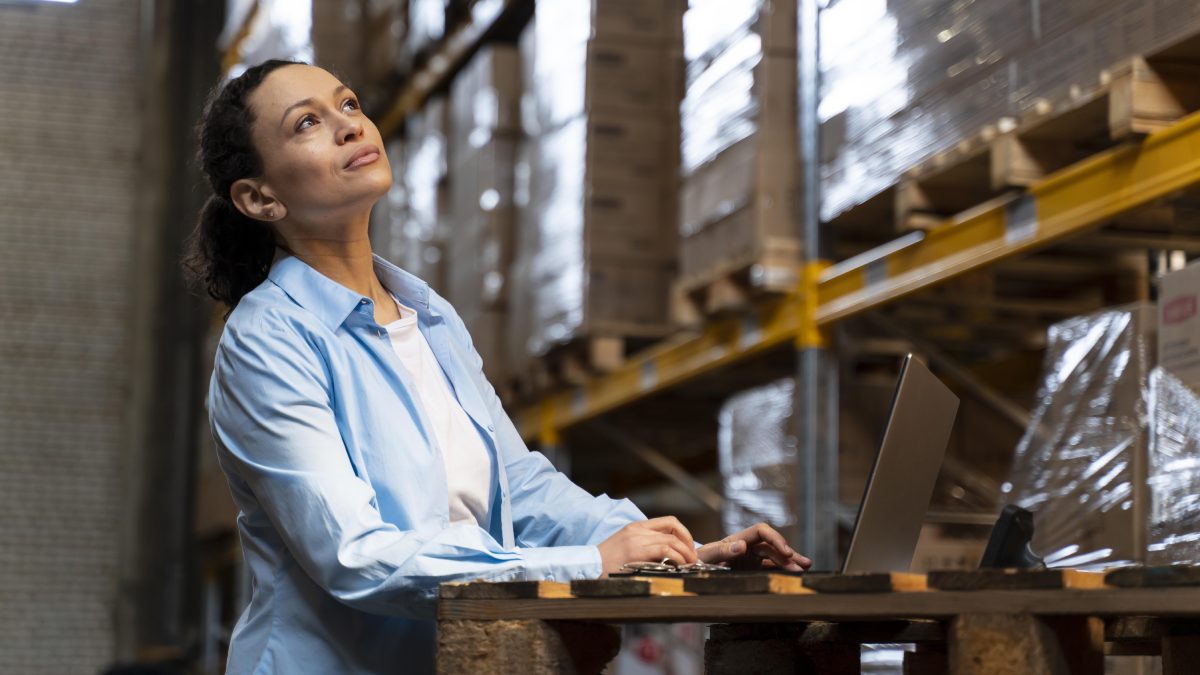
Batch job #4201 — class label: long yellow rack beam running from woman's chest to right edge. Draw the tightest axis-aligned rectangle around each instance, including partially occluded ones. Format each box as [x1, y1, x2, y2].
[516, 110, 1200, 443]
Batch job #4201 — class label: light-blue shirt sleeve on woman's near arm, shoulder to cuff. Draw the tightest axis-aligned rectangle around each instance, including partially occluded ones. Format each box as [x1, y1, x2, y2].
[209, 307, 600, 617]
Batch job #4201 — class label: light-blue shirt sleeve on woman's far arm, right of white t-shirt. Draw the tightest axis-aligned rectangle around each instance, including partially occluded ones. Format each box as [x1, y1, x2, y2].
[439, 302, 646, 550]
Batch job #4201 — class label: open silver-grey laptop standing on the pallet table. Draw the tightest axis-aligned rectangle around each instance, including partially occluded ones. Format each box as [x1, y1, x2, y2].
[841, 354, 959, 574]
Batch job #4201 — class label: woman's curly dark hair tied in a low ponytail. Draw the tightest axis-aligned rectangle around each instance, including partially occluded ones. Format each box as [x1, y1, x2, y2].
[180, 59, 307, 318]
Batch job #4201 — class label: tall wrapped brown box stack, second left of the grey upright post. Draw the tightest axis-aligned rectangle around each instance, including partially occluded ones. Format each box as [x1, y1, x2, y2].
[509, 0, 682, 368]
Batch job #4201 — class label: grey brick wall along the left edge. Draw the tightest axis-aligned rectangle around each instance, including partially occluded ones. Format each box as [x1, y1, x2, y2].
[0, 0, 142, 674]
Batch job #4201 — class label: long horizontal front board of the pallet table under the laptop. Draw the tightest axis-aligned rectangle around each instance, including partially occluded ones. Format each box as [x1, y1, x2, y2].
[438, 587, 1200, 623]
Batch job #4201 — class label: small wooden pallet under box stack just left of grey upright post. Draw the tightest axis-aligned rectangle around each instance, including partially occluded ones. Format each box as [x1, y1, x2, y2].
[671, 240, 800, 328]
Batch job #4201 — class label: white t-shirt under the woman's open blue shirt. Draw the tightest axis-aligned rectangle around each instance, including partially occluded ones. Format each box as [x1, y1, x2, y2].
[384, 295, 492, 528]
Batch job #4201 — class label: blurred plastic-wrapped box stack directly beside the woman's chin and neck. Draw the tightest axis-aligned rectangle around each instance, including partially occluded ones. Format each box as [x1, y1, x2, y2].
[371, 97, 446, 291]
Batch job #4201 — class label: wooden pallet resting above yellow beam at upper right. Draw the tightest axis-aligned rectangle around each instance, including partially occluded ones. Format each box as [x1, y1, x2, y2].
[833, 47, 1200, 233]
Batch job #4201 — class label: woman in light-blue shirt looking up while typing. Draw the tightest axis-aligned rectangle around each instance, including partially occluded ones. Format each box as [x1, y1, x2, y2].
[185, 61, 810, 674]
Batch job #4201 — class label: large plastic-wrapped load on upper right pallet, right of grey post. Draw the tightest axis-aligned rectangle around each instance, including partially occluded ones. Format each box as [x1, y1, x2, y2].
[818, 0, 1200, 220]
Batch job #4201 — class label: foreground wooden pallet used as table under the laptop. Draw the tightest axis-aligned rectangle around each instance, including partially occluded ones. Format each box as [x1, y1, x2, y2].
[439, 566, 1200, 675]
